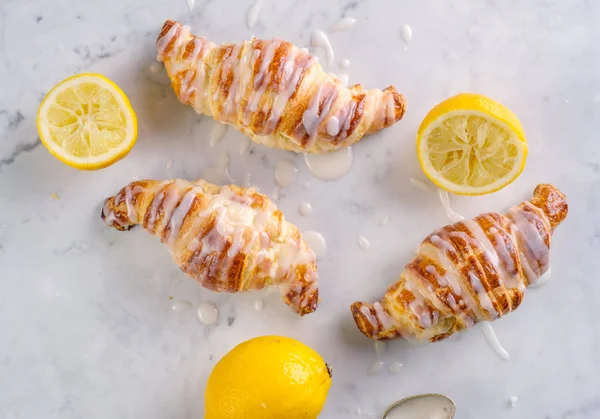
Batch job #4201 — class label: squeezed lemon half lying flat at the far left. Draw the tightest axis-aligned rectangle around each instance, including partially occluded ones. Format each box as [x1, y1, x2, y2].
[37, 73, 137, 170]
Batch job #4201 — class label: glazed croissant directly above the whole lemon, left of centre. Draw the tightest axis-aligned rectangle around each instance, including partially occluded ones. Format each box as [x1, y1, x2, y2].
[102, 179, 319, 315]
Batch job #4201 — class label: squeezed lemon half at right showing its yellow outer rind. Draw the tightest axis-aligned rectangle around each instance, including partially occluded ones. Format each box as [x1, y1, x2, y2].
[417, 93, 527, 195]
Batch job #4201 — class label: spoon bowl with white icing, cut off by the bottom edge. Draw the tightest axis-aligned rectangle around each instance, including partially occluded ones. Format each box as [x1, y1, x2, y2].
[383, 394, 456, 419]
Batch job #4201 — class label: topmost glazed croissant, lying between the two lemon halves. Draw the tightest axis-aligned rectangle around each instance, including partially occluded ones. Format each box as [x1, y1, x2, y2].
[156, 20, 406, 153]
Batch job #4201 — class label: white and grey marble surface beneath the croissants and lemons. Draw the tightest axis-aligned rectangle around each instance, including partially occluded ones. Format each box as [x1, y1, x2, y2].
[0, 0, 600, 419]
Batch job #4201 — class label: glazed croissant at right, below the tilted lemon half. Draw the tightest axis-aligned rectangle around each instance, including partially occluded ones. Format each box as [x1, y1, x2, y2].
[351, 184, 568, 342]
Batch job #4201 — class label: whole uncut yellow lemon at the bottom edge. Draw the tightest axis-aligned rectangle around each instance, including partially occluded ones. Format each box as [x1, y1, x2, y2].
[204, 336, 331, 419]
